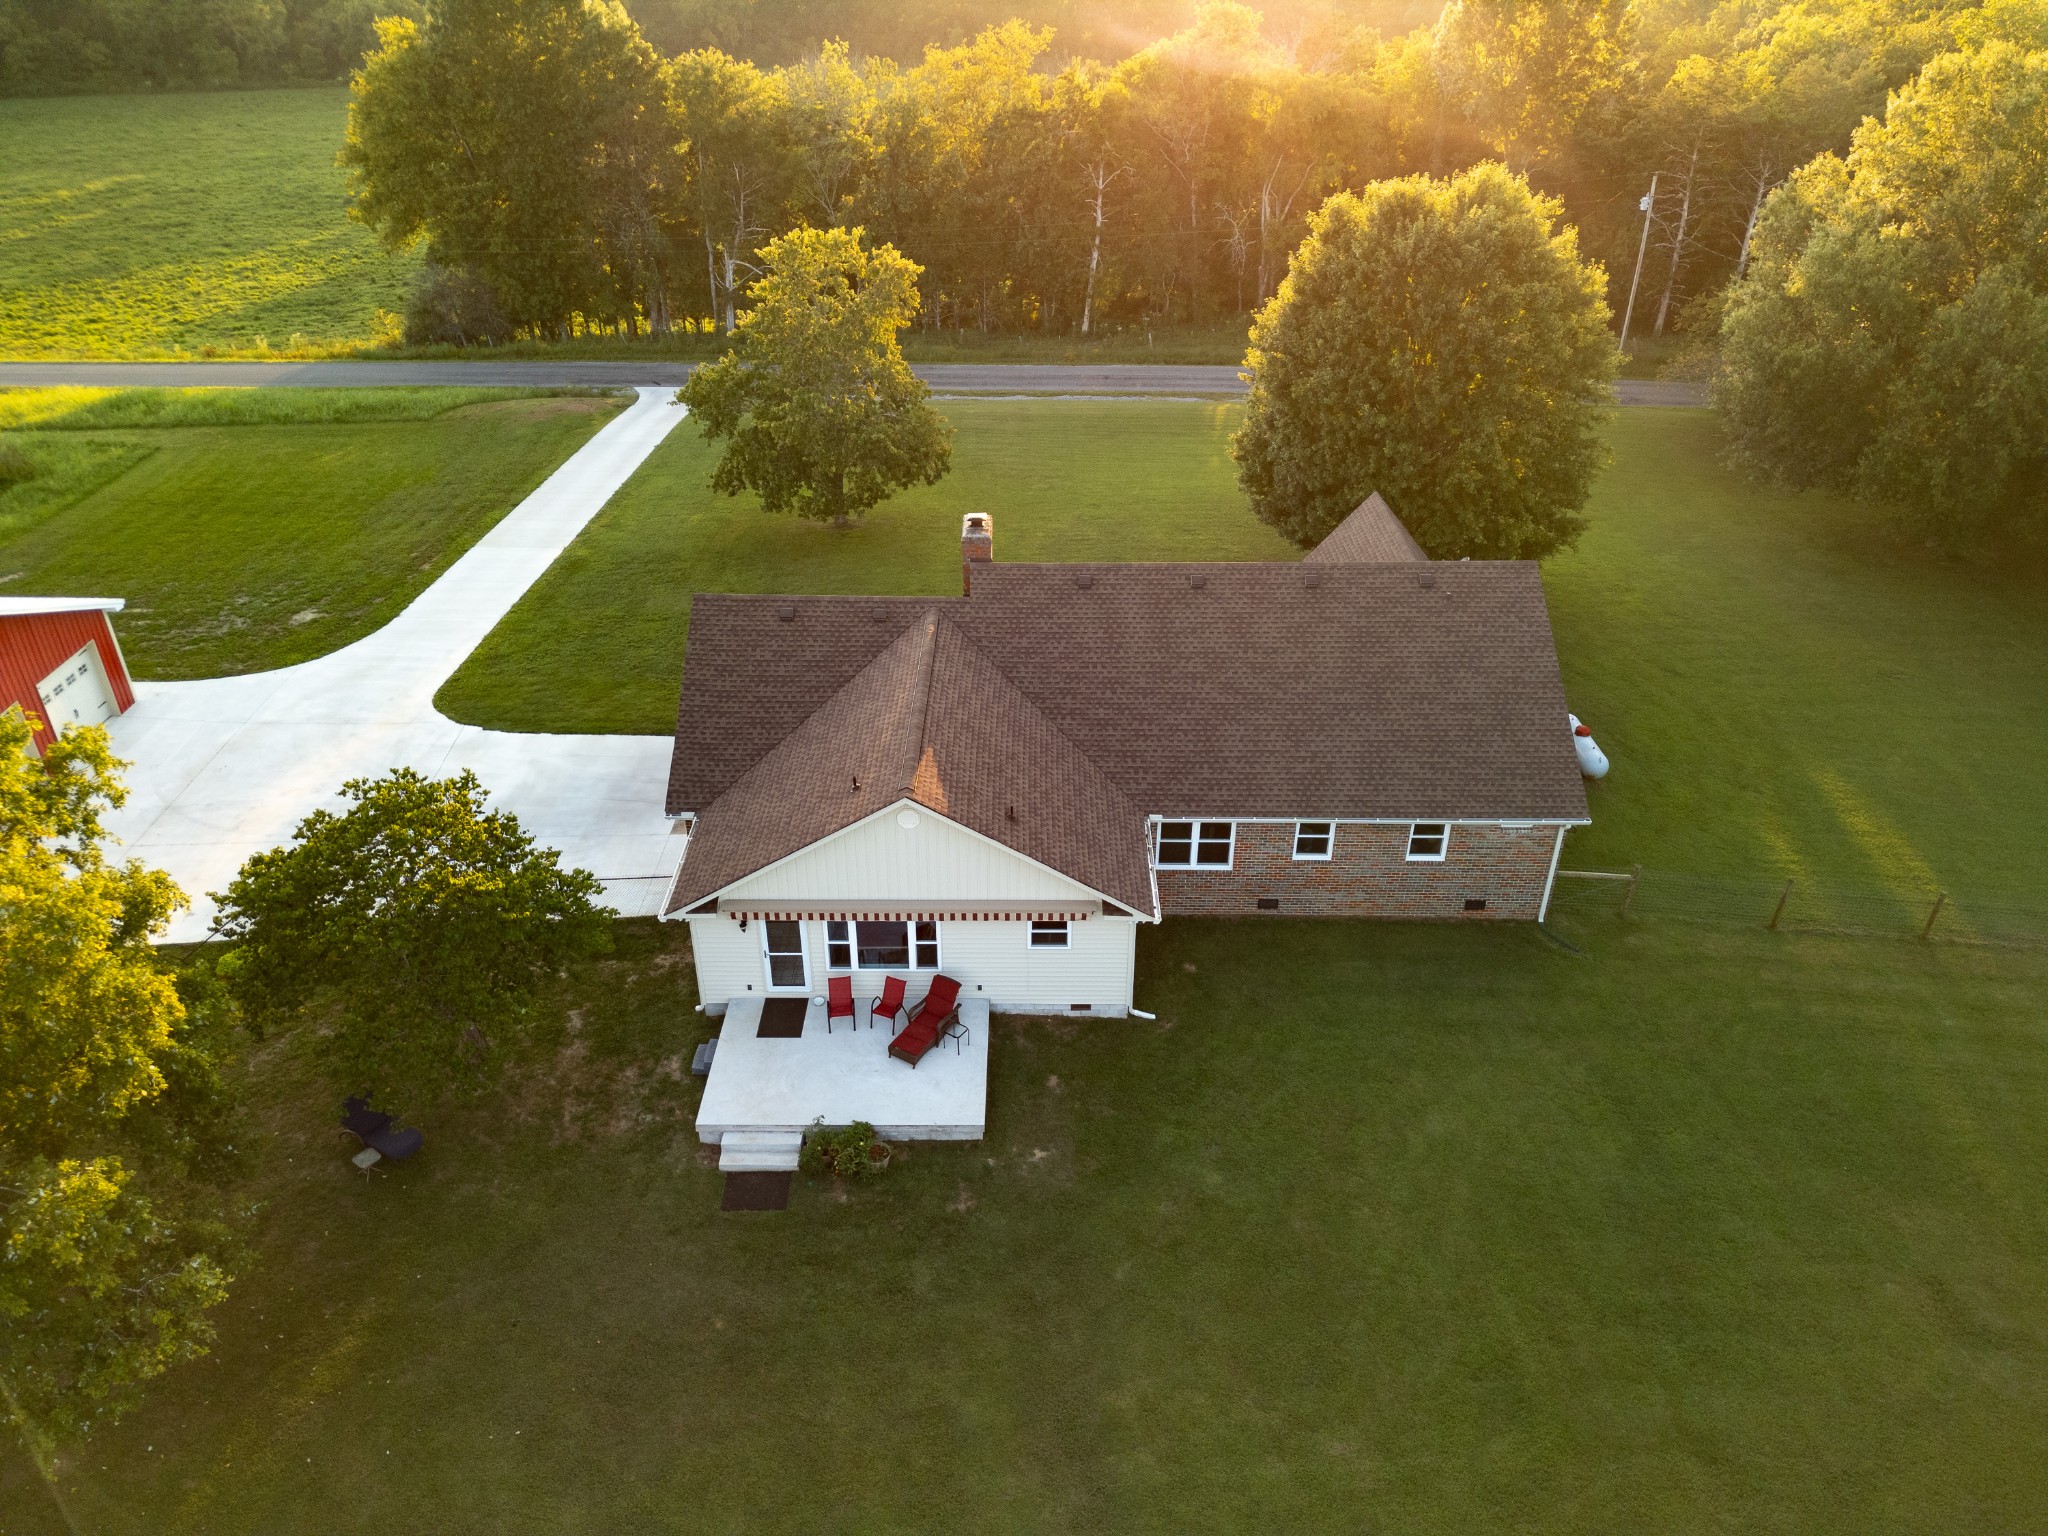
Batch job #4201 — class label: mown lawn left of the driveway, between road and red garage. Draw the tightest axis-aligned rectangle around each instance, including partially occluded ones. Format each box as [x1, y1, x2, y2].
[0, 389, 621, 678]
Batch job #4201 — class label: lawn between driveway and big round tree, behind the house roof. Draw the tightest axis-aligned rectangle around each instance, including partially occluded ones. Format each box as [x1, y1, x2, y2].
[436, 399, 1292, 731]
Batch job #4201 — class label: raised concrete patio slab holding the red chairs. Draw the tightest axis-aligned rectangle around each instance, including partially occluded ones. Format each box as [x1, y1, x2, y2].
[696, 997, 989, 1145]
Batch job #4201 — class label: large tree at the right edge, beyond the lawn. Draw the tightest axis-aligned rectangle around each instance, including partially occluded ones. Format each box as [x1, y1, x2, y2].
[1716, 18, 2048, 543]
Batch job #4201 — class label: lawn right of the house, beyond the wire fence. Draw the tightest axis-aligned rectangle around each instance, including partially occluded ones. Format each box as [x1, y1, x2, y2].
[1544, 410, 2048, 907]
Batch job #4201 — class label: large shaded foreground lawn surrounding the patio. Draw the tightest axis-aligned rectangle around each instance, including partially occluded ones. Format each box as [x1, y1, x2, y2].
[0, 920, 2048, 1536]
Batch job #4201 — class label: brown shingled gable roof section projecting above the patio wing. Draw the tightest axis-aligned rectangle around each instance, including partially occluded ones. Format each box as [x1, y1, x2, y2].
[668, 602, 1153, 913]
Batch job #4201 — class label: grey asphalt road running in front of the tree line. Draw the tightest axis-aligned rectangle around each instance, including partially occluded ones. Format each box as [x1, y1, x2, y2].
[0, 360, 1706, 406]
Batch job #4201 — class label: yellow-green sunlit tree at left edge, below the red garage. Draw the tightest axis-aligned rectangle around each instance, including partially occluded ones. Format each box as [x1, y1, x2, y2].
[0, 711, 231, 1466]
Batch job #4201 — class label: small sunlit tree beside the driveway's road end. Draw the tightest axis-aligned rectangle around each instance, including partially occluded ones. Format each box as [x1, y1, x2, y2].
[678, 229, 952, 522]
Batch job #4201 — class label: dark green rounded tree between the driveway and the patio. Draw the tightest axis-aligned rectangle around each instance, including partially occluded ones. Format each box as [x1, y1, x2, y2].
[217, 768, 610, 1100]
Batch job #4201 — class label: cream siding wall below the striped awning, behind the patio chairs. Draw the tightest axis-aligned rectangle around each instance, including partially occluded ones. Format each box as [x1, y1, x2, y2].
[688, 915, 1137, 1014]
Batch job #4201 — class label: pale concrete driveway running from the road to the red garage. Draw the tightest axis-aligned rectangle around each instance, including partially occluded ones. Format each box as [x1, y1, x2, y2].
[109, 387, 684, 942]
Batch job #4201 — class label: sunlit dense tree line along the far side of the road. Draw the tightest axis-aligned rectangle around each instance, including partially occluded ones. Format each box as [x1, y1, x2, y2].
[344, 0, 1998, 348]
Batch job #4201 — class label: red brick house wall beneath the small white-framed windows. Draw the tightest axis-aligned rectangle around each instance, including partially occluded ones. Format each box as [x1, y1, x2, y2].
[1159, 821, 1559, 922]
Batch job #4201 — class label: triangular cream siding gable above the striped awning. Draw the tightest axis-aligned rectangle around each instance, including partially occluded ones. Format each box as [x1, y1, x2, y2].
[721, 807, 1094, 901]
